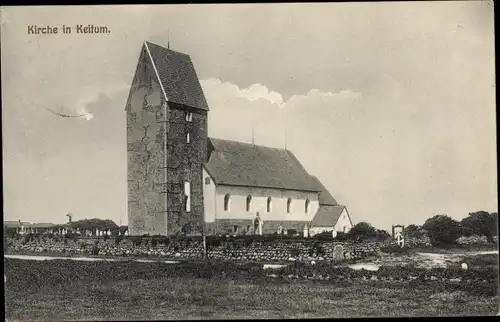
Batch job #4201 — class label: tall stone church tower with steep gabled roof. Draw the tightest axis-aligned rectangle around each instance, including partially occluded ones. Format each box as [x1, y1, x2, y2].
[125, 42, 209, 235]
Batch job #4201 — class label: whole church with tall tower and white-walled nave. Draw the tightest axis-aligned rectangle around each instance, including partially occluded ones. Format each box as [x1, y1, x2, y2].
[125, 42, 352, 236]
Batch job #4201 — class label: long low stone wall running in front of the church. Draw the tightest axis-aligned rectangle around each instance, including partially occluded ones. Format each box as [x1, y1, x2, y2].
[4, 237, 380, 262]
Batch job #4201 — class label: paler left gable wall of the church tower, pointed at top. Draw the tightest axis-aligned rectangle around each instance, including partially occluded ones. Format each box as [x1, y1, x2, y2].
[126, 48, 167, 234]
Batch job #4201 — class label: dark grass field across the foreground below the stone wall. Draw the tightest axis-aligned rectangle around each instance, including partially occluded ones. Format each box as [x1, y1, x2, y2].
[5, 258, 499, 321]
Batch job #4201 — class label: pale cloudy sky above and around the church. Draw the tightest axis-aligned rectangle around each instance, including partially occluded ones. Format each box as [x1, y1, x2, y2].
[1, 1, 498, 230]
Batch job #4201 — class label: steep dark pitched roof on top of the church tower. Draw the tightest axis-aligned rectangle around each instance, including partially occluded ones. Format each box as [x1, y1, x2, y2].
[145, 42, 209, 111]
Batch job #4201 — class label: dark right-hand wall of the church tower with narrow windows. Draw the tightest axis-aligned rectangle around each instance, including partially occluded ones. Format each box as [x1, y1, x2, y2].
[167, 103, 207, 235]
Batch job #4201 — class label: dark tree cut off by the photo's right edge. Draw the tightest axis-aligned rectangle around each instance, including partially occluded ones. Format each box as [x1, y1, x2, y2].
[461, 211, 498, 243]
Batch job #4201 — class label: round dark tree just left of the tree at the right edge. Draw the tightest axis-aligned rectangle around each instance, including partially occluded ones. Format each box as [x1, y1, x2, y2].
[422, 215, 461, 245]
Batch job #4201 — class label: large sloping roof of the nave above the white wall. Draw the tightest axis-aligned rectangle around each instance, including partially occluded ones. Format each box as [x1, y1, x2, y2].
[205, 138, 321, 192]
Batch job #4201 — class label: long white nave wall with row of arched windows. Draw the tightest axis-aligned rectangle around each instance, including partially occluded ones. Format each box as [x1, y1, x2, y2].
[215, 185, 319, 221]
